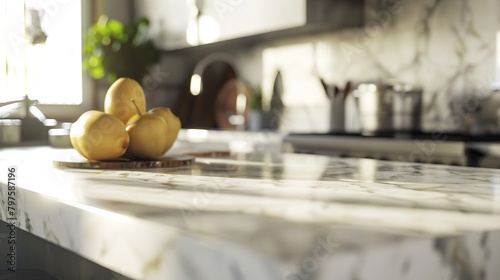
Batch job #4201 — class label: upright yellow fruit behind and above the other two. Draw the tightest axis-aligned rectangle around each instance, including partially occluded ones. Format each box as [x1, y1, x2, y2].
[104, 78, 146, 124]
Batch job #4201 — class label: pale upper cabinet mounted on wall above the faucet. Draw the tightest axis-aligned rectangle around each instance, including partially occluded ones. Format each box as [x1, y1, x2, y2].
[135, 0, 363, 50]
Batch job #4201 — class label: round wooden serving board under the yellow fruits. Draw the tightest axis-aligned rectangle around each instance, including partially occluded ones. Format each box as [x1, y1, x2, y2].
[53, 156, 194, 169]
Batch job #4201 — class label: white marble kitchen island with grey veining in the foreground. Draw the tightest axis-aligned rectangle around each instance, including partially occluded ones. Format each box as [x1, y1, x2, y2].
[0, 134, 500, 280]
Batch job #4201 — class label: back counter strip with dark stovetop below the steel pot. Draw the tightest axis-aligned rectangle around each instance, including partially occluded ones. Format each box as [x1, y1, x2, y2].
[283, 132, 500, 168]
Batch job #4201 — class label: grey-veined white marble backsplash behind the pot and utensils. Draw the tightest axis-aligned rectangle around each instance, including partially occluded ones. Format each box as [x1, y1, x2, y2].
[257, 0, 500, 132]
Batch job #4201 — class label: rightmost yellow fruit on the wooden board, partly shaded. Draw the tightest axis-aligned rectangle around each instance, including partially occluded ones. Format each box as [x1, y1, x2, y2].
[126, 114, 168, 160]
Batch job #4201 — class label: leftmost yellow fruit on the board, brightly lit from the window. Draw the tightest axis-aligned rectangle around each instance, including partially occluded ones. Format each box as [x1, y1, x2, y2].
[70, 110, 130, 160]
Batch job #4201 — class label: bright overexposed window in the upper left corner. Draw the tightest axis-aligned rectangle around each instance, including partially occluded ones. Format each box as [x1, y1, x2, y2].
[0, 0, 83, 105]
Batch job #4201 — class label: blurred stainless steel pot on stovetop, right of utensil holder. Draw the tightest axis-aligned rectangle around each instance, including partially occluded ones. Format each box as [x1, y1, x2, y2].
[354, 83, 422, 134]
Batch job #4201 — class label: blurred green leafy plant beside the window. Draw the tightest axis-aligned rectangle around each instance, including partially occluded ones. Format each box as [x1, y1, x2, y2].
[83, 16, 161, 83]
